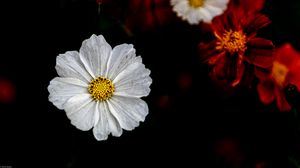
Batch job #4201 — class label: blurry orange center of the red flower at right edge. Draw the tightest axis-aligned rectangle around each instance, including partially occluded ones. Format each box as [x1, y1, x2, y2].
[272, 61, 289, 86]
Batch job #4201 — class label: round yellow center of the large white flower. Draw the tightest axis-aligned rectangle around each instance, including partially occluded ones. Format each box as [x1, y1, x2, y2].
[88, 76, 115, 101]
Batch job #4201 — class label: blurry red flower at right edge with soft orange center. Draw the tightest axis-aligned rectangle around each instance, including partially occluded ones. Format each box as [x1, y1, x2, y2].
[256, 43, 300, 111]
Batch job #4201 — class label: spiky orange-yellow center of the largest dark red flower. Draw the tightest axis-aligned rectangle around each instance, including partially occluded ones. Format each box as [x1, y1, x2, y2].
[215, 30, 247, 54]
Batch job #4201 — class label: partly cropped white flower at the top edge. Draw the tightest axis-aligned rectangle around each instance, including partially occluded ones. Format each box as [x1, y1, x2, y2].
[171, 0, 229, 25]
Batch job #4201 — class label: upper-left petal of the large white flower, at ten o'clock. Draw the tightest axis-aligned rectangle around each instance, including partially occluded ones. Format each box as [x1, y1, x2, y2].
[55, 51, 92, 82]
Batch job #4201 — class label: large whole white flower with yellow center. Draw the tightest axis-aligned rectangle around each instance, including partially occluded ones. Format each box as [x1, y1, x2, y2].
[48, 35, 152, 140]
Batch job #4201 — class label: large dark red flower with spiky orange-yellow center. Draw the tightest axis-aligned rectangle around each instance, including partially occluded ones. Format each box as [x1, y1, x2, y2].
[199, 1, 274, 86]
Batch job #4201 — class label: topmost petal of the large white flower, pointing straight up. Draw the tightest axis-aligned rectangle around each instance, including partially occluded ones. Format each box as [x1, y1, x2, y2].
[79, 34, 111, 78]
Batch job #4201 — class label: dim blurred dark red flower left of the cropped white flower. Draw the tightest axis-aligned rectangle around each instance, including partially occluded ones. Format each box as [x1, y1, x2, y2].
[126, 0, 173, 30]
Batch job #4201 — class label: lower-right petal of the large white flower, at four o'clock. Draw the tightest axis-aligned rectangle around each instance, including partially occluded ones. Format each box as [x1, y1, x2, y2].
[107, 96, 148, 130]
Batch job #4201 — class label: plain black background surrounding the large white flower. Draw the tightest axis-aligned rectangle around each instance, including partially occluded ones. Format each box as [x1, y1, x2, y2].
[0, 0, 300, 168]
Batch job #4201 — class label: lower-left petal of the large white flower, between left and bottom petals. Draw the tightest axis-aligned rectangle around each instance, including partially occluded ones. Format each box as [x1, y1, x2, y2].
[64, 94, 98, 131]
